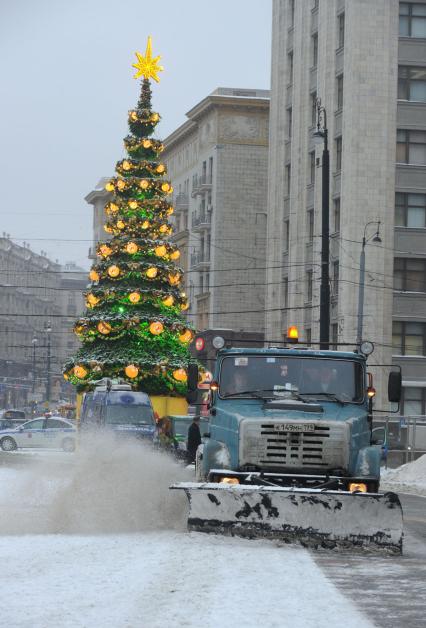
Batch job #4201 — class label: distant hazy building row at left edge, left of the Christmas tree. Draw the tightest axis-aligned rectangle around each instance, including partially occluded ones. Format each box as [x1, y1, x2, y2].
[0, 234, 86, 408]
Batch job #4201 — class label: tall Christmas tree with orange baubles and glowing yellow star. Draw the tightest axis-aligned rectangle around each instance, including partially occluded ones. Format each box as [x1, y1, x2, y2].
[64, 37, 193, 395]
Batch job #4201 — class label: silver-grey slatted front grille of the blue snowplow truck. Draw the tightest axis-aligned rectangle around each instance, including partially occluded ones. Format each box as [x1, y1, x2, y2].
[240, 419, 349, 469]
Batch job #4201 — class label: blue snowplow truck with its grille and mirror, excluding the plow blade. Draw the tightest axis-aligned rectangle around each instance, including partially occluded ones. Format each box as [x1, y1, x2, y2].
[196, 348, 401, 492]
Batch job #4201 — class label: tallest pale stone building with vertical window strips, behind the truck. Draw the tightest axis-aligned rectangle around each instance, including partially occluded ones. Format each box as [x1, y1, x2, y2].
[266, 0, 426, 414]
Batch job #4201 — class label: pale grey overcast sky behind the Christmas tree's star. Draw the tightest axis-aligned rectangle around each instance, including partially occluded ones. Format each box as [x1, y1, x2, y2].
[0, 0, 271, 268]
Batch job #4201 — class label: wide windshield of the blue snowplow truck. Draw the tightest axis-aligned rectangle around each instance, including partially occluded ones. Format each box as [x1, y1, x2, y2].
[219, 355, 364, 402]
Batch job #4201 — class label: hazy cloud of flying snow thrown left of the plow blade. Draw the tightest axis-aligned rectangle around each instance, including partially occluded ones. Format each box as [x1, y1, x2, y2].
[0, 434, 191, 534]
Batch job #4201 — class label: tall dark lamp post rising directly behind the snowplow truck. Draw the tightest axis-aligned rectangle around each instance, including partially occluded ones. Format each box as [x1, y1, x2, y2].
[314, 98, 330, 349]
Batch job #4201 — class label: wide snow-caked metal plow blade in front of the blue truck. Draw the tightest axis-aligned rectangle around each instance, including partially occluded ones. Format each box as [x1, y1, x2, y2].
[170, 482, 403, 554]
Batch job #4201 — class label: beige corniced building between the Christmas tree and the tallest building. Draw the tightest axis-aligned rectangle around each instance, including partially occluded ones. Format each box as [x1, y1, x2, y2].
[164, 88, 269, 332]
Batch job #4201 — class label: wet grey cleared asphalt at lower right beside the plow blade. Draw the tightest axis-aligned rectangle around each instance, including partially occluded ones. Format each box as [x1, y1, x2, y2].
[313, 494, 426, 628]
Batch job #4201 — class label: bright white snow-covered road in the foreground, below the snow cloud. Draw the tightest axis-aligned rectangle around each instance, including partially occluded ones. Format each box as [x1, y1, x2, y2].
[0, 531, 372, 628]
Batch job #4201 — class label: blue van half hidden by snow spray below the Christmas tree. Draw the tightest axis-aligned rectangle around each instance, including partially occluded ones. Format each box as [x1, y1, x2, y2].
[80, 384, 157, 441]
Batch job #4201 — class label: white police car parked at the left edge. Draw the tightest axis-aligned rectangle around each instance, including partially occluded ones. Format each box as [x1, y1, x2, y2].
[0, 416, 77, 451]
